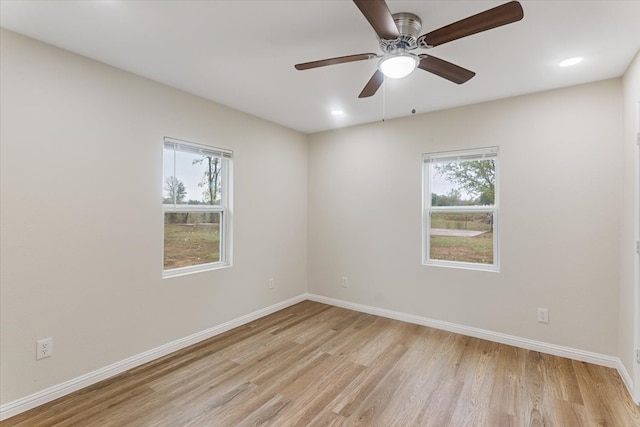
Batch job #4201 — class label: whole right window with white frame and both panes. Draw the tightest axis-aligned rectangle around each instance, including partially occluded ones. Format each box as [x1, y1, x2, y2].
[422, 147, 498, 271]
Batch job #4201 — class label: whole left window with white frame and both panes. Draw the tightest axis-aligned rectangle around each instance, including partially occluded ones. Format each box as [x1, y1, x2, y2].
[162, 138, 232, 277]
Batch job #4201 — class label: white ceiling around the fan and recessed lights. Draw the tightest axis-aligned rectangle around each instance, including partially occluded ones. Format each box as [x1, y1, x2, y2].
[0, 0, 640, 133]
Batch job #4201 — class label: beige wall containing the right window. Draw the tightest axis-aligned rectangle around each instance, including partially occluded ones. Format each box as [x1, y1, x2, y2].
[309, 79, 622, 356]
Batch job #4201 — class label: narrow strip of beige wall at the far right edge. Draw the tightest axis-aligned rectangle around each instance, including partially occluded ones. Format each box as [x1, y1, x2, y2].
[619, 53, 640, 402]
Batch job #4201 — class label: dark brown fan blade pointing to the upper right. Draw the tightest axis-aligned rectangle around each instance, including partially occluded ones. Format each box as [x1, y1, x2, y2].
[418, 1, 524, 47]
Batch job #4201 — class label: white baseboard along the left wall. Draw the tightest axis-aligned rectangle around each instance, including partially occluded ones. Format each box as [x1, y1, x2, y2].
[0, 294, 307, 421]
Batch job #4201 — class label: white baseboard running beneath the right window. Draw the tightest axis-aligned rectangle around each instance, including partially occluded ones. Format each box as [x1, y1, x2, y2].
[306, 294, 633, 402]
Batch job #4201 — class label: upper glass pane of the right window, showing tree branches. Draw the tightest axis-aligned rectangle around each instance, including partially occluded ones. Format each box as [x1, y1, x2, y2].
[429, 159, 496, 206]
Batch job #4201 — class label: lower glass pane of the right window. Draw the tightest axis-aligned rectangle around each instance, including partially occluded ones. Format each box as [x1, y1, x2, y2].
[429, 212, 493, 264]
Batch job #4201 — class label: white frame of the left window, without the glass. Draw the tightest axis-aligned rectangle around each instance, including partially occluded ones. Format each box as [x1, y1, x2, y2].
[162, 137, 233, 278]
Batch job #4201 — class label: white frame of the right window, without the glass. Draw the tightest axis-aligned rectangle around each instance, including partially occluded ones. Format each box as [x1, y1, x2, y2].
[422, 147, 500, 272]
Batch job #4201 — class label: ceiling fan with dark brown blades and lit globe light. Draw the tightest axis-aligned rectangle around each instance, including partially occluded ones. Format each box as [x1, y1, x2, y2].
[295, 0, 524, 98]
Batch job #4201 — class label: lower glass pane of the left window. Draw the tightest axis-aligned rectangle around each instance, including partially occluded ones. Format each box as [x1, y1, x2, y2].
[164, 212, 221, 269]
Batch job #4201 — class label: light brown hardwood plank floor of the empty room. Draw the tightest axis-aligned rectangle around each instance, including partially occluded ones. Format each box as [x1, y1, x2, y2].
[1, 301, 640, 427]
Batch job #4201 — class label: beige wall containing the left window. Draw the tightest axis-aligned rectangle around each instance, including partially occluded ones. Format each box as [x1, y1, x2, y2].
[0, 31, 307, 404]
